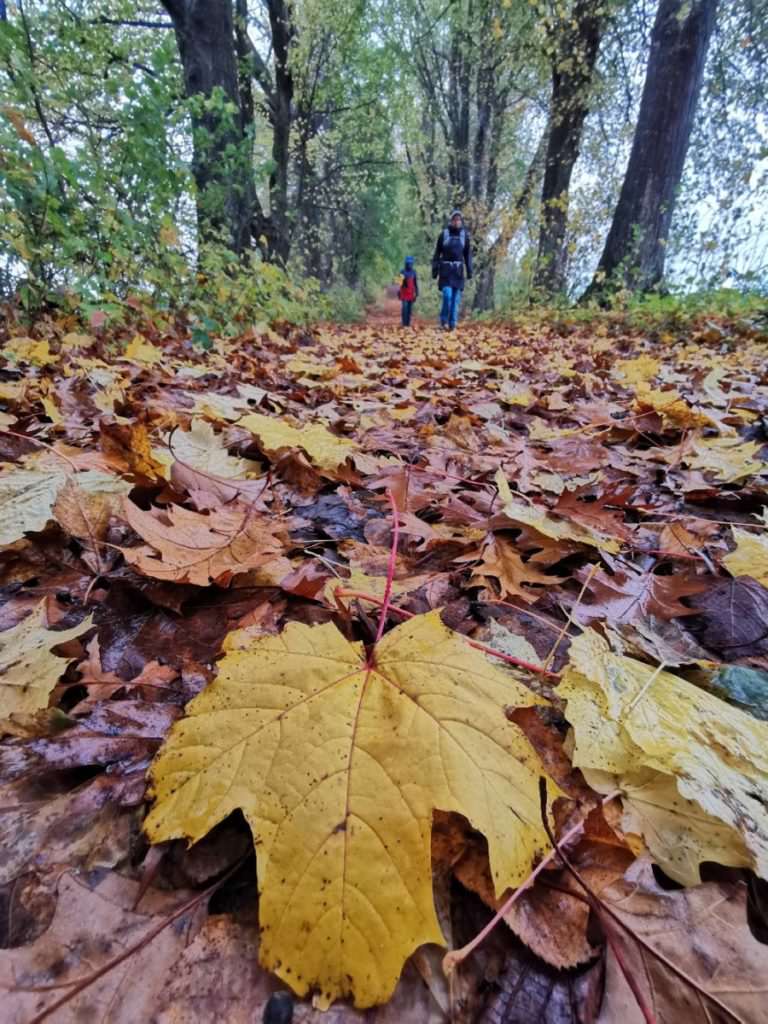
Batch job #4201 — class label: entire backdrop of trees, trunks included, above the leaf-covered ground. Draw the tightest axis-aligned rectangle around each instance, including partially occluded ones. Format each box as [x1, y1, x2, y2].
[0, 0, 768, 312]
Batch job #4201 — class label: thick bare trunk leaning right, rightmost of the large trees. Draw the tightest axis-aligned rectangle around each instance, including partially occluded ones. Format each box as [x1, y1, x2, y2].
[584, 0, 717, 298]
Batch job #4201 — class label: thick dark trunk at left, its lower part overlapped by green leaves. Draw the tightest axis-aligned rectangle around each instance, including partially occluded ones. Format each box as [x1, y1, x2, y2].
[163, 0, 255, 254]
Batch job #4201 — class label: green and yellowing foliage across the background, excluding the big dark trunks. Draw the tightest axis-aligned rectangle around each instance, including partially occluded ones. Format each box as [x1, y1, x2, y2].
[0, 0, 768, 323]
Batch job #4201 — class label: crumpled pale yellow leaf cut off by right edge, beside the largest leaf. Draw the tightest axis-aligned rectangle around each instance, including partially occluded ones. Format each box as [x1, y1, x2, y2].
[558, 629, 768, 884]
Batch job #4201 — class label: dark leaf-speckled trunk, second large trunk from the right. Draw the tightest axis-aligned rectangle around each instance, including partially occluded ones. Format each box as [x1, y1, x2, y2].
[534, 0, 605, 295]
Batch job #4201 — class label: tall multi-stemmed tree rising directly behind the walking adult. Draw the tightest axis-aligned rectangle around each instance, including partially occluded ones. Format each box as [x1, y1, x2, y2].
[388, 0, 542, 308]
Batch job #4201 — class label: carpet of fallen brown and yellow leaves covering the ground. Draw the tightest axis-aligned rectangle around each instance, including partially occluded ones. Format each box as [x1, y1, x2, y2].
[0, 313, 768, 1024]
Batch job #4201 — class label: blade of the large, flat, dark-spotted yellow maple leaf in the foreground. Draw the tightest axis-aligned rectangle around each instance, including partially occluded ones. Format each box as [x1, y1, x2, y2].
[145, 611, 558, 1008]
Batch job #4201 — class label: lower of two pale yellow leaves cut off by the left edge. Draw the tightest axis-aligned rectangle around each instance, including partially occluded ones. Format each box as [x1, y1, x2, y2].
[0, 600, 93, 718]
